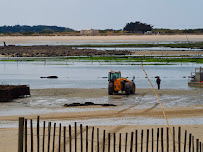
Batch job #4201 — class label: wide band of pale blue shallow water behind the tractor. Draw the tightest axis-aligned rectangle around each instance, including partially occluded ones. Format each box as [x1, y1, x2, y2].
[0, 61, 203, 89]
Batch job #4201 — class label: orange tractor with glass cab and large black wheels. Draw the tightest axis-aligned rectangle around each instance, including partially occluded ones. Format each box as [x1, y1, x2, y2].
[108, 70, 136, 95]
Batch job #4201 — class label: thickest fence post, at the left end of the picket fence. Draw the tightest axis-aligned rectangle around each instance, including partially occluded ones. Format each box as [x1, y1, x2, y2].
[18, 117, 24, 152]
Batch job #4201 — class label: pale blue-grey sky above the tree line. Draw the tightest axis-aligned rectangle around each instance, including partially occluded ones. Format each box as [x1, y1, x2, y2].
[0, 0, 203, 30]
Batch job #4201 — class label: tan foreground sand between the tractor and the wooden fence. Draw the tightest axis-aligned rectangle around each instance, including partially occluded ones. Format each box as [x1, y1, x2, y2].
[0, 88, 203, 152]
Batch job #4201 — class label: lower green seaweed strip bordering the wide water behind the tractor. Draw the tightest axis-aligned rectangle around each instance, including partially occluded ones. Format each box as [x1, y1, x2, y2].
[0, 56, 203, 65]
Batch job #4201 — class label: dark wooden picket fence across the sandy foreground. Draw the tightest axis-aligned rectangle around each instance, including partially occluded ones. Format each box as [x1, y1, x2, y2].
[18, 116, 203, 152]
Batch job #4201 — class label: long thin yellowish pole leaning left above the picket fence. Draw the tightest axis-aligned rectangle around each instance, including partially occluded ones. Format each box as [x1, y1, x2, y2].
[141, 64, 177, 152]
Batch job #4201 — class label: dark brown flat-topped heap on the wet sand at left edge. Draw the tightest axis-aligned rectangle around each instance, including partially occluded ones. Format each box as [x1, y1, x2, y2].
[0, 85, 30, 102]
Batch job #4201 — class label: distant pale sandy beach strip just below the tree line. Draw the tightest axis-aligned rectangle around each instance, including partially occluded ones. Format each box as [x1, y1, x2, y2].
[0, 35, 203, 44]
